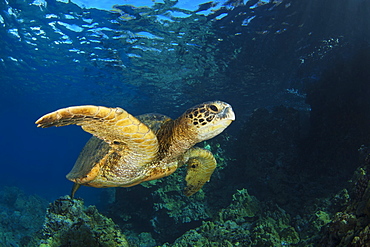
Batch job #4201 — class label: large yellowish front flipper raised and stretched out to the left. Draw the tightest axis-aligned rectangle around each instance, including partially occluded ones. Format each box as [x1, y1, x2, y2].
[36, 105, 158, 167]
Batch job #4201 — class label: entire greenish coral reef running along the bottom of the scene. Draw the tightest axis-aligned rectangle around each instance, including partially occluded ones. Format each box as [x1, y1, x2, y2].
[0, 141, 370, 247]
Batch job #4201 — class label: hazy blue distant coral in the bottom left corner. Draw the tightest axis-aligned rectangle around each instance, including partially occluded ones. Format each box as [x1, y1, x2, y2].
[0, 187, 47, 247]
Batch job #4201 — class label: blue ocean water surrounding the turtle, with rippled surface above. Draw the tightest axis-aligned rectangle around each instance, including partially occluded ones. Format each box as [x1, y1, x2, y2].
[0, 0, 370, 246]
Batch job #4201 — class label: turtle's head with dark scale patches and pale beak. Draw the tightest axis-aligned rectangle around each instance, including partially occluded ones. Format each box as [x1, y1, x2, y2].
[182, 101, 235, 142]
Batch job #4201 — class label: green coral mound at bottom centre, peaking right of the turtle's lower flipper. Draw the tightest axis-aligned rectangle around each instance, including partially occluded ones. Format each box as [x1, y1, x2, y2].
[163, 189, 300, 247]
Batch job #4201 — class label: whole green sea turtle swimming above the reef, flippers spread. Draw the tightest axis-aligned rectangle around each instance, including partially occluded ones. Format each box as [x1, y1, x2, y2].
[36, 101, 235, 197]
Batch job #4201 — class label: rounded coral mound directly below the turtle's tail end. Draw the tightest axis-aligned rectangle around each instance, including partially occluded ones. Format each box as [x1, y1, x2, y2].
[40, 196, 128, 247]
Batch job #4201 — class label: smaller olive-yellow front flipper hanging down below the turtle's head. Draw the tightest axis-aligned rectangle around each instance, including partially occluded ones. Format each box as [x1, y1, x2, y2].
[184, 147, 217, 196]
